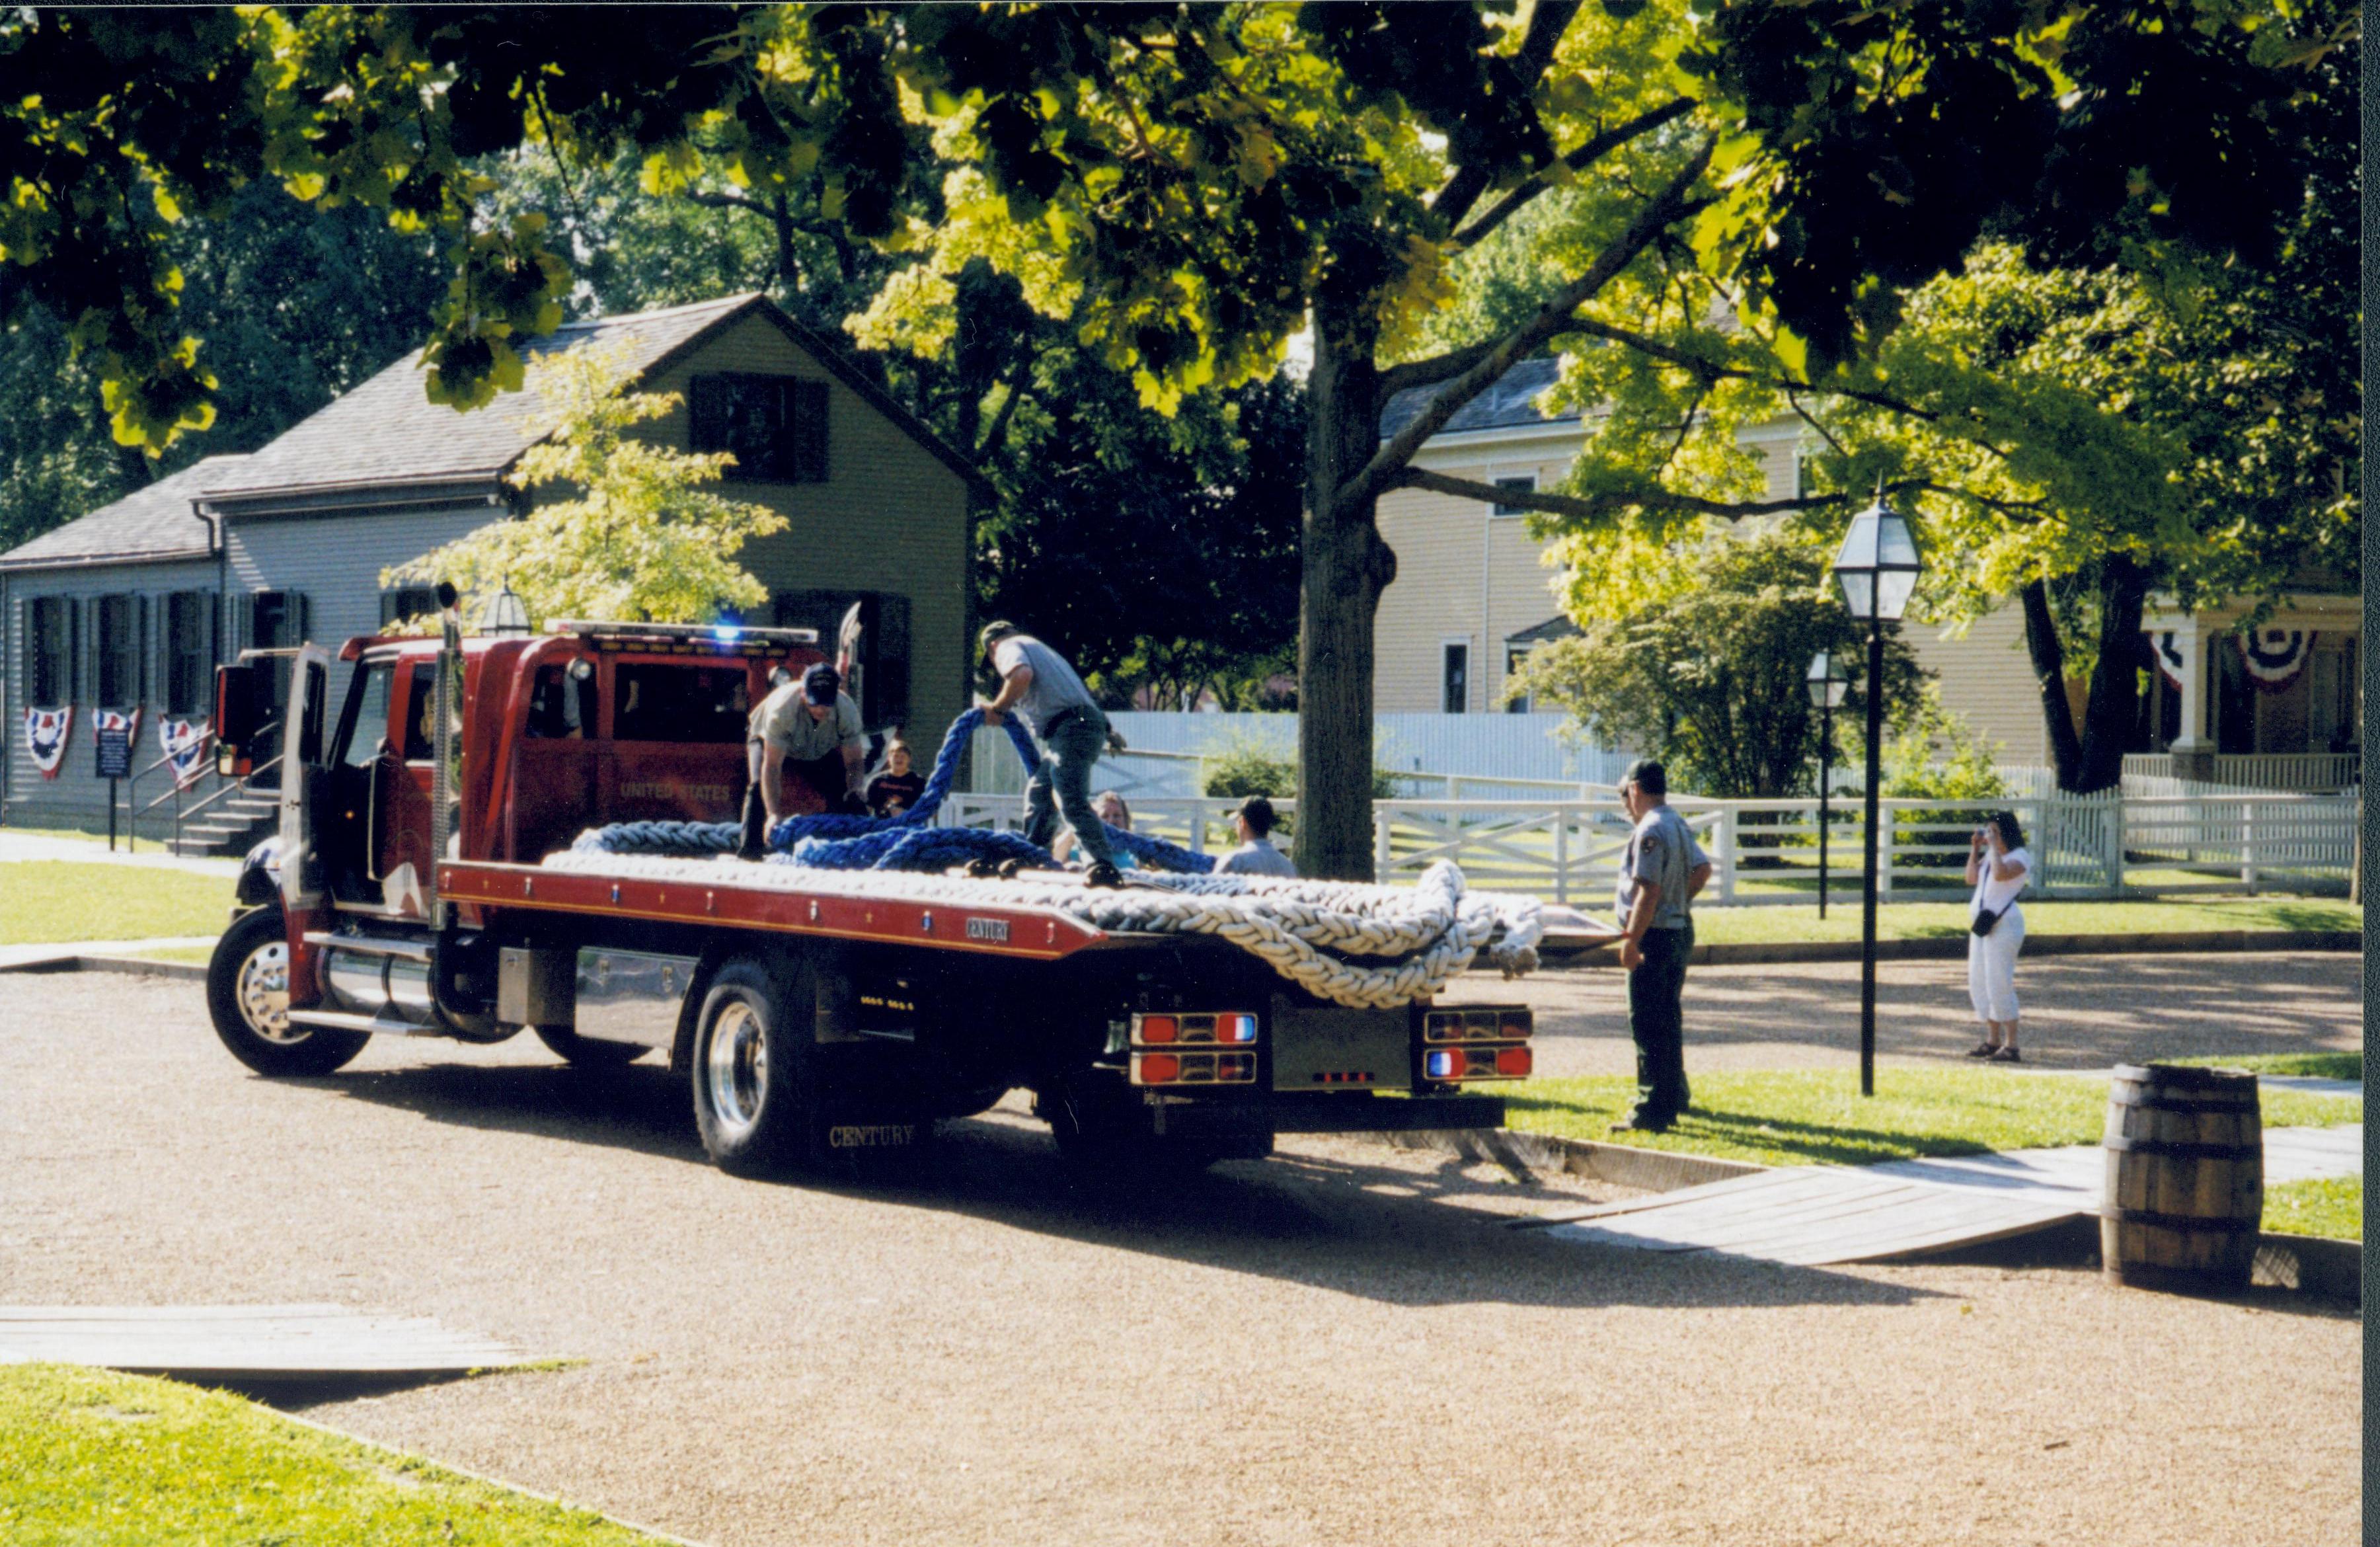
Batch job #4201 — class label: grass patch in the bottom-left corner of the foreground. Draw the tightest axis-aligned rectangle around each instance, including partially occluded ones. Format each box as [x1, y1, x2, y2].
[0, 1364, 657, 1547]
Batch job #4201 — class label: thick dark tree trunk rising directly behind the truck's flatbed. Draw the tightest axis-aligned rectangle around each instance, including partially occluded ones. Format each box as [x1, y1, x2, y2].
[1292, 300, 1397, 881]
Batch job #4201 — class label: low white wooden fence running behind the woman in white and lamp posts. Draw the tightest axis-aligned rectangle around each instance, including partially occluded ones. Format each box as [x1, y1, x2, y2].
[940, 790, 2359, 904]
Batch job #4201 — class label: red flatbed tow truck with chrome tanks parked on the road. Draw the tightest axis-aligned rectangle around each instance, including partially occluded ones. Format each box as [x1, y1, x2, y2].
[207, 614, 1533, 1173]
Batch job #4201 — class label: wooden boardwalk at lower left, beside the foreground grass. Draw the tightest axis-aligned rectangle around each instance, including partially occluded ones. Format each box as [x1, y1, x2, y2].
[0, 1304, 528, 1380]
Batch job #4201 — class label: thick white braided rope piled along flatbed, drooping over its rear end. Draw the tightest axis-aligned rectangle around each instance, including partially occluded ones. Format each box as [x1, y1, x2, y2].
[545, 850, 1545, 1007]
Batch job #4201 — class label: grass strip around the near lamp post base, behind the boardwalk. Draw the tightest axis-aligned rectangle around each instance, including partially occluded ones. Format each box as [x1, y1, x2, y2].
[1504, 1068, 2363, 1166]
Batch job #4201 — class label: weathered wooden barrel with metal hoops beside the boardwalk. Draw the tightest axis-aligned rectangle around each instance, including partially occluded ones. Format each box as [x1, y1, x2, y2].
[2099, 1064, 2264, 1292]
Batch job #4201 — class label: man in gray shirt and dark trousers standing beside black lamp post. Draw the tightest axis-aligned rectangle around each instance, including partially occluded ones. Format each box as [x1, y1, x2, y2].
[1611, 757, 1711, 1133]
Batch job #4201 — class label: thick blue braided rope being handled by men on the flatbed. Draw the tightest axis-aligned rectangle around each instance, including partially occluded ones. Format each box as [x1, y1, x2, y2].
[571, 709, 1214, 873]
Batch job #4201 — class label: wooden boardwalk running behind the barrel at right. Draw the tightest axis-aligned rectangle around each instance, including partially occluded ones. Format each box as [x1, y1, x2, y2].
[1523, 1123, 2363, 1266]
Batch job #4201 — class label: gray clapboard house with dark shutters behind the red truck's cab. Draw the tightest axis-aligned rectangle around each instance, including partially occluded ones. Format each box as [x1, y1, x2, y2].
[0, 295, 987, 848]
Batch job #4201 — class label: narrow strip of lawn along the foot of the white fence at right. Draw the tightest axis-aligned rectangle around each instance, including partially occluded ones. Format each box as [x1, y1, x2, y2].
[1695, 897, 2363, 945]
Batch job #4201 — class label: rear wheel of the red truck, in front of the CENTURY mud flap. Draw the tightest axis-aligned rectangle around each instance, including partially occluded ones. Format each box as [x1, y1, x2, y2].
[693, 957, 812, 1175]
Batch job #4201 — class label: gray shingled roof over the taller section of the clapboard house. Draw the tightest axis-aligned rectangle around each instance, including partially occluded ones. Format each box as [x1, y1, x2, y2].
[210, 293, 759, 500]
